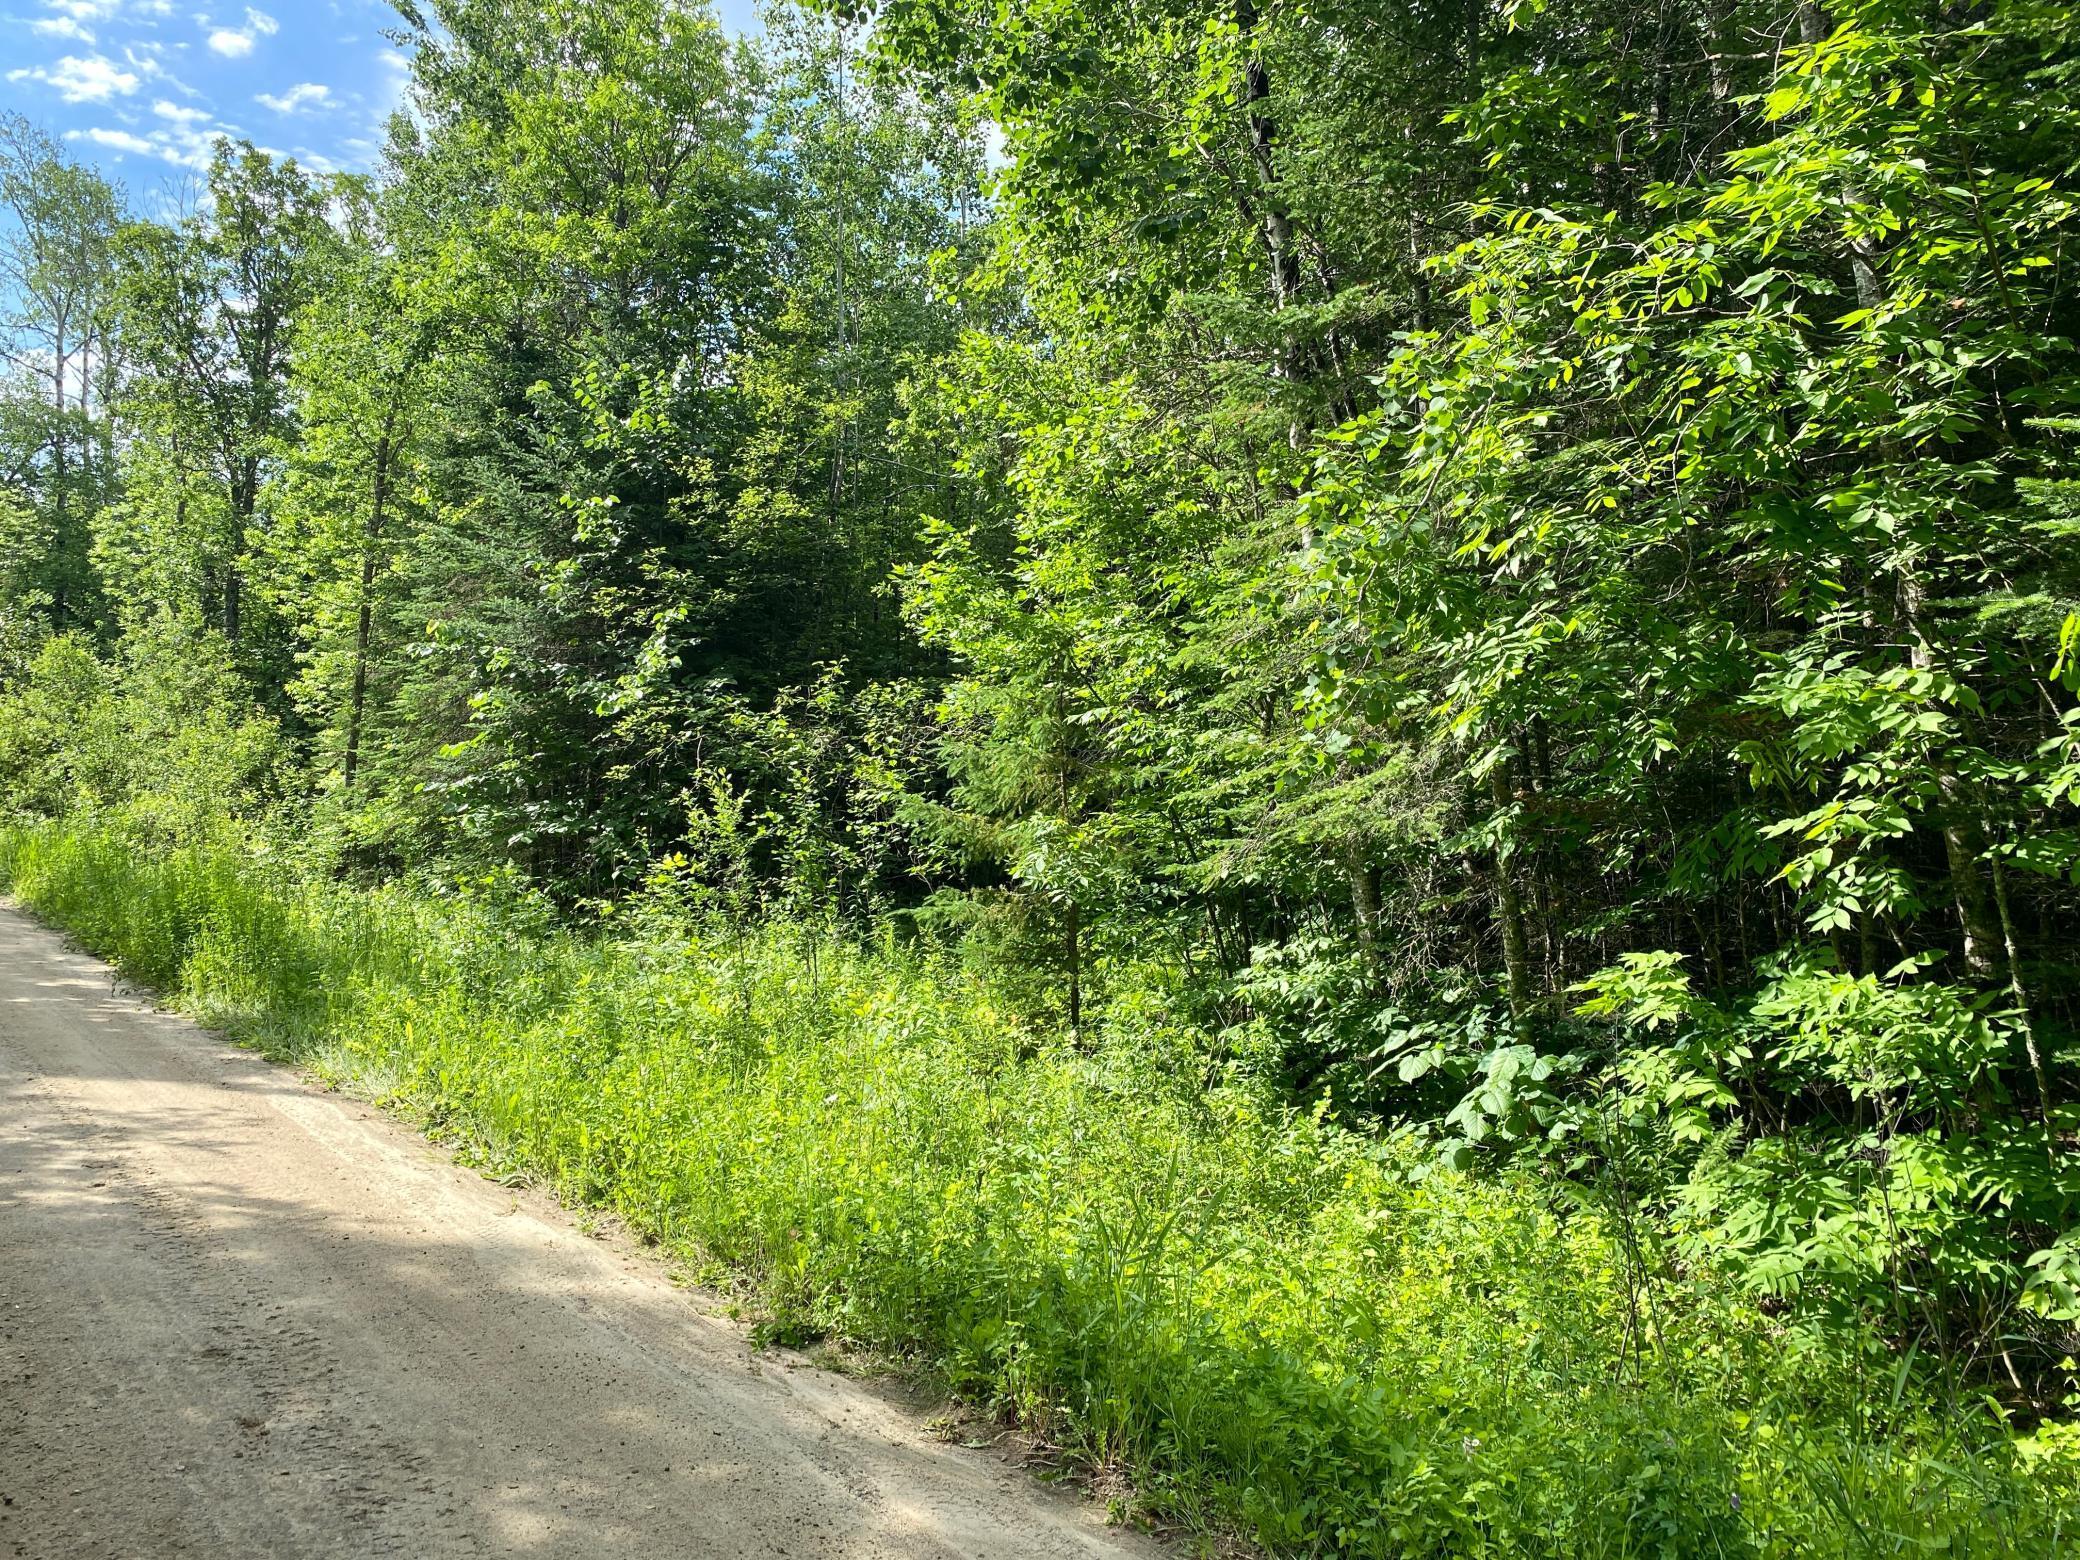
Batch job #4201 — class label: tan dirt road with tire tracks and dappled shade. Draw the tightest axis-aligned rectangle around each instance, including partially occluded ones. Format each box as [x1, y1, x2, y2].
[0, 907, 1152, 1560]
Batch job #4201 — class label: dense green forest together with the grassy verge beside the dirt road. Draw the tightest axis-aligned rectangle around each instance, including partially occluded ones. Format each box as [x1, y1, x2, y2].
[0, 0, 2080, 1558]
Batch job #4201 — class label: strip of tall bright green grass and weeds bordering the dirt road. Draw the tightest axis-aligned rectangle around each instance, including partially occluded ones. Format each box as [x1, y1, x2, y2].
[0, 826, 2080, 1560]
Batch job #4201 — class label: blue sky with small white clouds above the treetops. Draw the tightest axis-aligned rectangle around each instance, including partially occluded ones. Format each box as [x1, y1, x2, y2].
[0, 0, 751, 206]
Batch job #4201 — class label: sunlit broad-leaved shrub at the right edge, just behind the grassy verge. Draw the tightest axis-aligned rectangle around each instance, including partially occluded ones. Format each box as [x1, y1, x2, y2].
[1585, 953, 2080, 1381]
